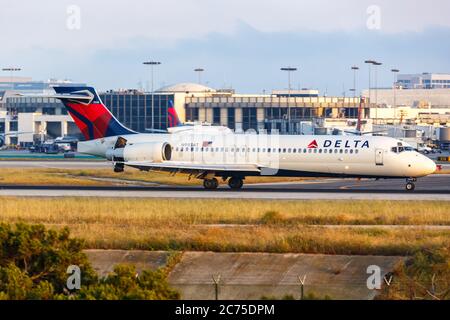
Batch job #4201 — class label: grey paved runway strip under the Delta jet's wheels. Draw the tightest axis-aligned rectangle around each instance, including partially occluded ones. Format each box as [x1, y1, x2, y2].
[0, 175, 450, 201]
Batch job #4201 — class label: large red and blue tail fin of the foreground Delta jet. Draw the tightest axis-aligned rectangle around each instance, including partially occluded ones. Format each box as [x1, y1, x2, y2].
[53, 86, 137, 140]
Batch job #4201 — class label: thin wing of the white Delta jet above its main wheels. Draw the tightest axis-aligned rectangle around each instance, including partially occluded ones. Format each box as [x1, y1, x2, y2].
[123, 161, 261, 173]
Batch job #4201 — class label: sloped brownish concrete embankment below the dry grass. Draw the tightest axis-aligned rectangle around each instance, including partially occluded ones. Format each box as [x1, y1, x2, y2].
[86, 250, 405, 300]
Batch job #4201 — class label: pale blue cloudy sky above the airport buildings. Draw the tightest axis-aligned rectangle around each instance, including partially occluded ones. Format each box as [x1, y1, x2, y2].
[0, 0, 450, 95]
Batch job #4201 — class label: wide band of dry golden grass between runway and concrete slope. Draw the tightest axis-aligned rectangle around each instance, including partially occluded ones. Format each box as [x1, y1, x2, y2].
[0, 198, 450, 255]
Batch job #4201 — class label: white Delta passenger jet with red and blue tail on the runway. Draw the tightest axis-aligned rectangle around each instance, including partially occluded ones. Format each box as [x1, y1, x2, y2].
[53, 86, 436, 191]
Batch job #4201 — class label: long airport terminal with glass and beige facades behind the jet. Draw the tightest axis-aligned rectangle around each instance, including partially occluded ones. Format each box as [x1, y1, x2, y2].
[0, 78, 450, 146]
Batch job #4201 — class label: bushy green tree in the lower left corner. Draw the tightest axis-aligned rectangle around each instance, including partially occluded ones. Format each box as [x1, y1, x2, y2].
[0, 223, 179, 300]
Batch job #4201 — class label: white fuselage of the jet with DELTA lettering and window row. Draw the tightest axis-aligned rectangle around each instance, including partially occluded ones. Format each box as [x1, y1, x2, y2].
[79, 132, 436, 178]
